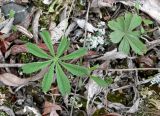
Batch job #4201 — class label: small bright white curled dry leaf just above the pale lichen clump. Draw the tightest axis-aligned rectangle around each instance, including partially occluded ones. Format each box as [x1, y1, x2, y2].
[74, 18, 97, 33]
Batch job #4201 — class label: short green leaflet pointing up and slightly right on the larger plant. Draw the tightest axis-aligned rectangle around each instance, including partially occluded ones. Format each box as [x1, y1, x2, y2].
[57, 37, 69, 57]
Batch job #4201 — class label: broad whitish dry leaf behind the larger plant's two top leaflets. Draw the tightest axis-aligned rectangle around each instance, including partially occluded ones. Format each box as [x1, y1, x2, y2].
[50, 19, 68, 44]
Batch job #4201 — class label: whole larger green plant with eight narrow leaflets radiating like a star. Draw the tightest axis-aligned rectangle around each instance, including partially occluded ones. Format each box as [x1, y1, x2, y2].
[22, 31, 90, 95]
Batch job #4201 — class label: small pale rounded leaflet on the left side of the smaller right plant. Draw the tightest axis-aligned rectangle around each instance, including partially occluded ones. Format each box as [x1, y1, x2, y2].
[110, 30, 125, 43]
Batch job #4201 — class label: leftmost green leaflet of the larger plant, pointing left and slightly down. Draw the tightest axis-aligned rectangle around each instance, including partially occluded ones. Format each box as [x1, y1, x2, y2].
[22, 60, 52, 74]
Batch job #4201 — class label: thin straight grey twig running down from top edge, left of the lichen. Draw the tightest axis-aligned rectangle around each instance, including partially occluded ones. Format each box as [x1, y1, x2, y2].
[83, 0, 90, 47]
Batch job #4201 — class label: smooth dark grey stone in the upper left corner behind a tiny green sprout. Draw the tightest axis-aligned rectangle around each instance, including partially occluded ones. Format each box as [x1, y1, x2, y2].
[1, 3, 28, 24]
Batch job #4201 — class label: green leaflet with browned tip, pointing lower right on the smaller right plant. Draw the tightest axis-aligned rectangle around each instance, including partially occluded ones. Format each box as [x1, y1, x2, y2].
[128, 35, 147, 55]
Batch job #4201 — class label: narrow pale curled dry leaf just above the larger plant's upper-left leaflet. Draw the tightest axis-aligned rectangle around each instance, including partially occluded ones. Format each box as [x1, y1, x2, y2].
[16, 25, 33, 38]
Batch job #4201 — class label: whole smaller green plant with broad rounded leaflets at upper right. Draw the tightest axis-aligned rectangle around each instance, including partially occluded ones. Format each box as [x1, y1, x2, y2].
[108, 13, 147, 55]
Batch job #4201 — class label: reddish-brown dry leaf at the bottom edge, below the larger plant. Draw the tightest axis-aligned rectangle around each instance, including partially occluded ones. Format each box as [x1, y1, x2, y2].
[42, 101, 62, 116]
